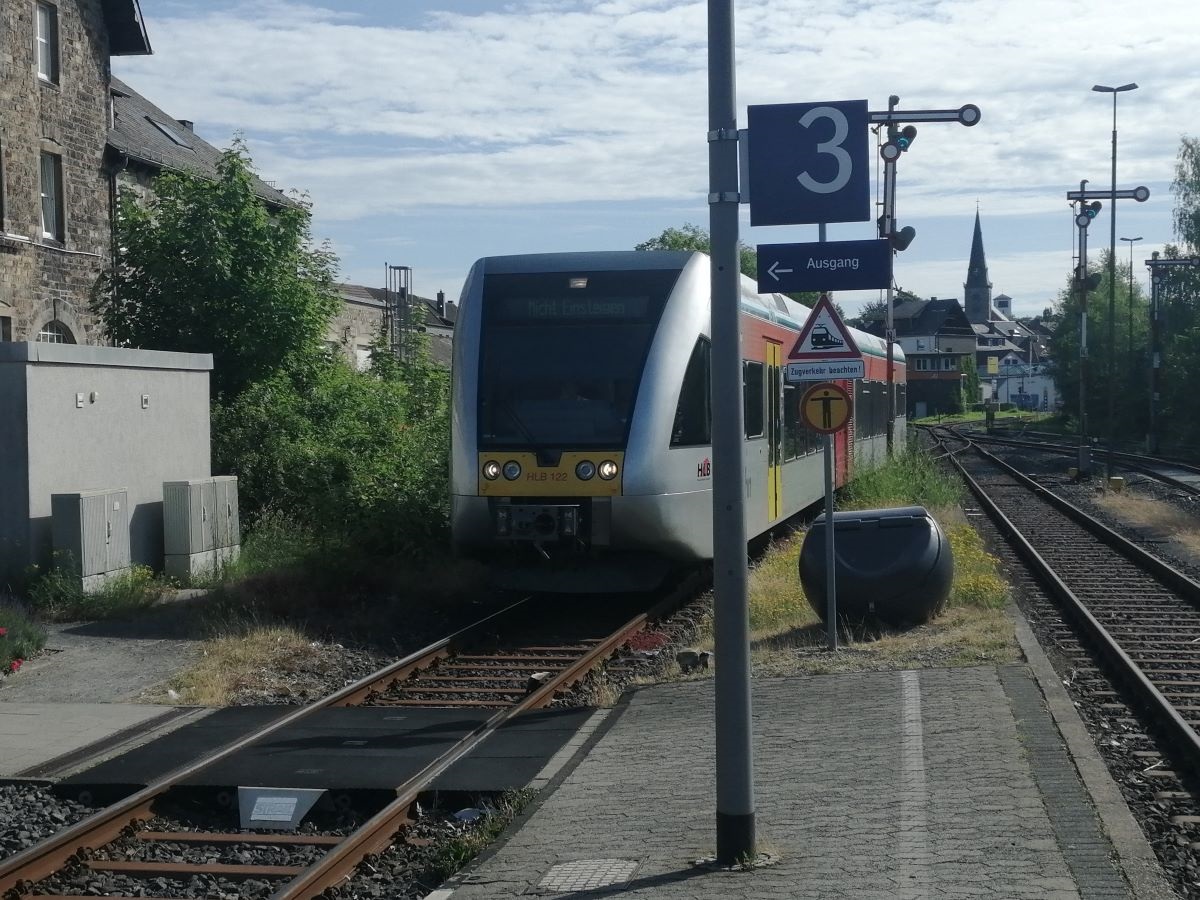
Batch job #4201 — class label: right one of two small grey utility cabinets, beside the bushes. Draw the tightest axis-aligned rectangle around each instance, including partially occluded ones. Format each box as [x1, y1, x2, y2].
[162, 475, 241, 580]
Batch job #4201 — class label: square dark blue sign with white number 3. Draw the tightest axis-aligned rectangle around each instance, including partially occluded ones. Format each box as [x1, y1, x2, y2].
[746, 100, 871, 226]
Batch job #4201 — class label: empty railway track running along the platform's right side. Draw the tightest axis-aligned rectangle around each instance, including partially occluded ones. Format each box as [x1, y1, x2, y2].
[935, 430, 1200, 774]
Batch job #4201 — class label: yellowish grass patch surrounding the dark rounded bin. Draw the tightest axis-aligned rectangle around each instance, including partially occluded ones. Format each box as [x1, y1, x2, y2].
[691, 441, 1020, 676]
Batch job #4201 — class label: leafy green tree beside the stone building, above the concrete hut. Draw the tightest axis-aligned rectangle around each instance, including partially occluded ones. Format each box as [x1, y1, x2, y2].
[92, 140, 340, 398]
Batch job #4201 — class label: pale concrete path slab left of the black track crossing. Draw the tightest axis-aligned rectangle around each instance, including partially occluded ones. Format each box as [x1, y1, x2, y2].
[0, 702, 186, 778]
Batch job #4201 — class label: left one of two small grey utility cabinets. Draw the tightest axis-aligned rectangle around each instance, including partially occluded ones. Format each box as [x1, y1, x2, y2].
[50, 488, 130, 592]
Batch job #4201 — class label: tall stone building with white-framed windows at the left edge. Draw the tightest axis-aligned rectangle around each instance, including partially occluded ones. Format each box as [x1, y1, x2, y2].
[0, 0, 150, 343]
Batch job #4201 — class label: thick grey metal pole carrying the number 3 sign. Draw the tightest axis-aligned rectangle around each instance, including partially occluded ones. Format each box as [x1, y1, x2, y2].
[708, 0, 756, 865]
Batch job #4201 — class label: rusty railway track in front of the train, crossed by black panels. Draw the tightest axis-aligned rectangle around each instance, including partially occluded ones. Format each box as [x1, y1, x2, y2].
[0, 586, 694, 900]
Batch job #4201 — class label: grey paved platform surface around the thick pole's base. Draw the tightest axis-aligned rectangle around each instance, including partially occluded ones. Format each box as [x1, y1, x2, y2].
[452, 666, 1130, 900]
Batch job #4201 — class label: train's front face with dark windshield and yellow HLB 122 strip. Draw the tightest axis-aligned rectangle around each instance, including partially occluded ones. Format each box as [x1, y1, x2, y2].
[451, 252, 686, 592]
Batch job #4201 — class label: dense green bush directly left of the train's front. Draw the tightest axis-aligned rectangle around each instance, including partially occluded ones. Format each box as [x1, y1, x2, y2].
[212, 343, 450, 558]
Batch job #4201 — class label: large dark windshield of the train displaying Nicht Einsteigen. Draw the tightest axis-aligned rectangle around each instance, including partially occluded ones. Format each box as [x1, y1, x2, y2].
[479, 269, 679, 449]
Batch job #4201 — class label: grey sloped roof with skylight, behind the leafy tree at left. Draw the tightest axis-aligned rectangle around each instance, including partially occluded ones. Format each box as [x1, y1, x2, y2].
[108, 78, 295, 208]
